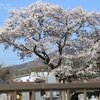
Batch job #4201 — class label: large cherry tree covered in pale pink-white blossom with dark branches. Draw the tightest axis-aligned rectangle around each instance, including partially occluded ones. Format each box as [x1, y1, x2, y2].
[0, 1, 100, 82]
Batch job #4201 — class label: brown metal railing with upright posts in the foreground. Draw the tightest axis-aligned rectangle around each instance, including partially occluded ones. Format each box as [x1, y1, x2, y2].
[0, 83, 100, 100]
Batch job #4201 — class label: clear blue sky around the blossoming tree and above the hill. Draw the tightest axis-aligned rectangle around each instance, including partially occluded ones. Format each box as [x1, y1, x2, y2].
[0, 0, 100, 66]
